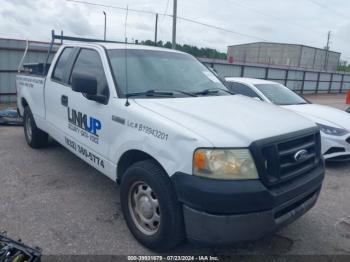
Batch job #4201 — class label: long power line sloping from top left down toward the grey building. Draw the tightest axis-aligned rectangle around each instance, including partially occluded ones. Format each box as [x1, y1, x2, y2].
[66, 0, 266, 41]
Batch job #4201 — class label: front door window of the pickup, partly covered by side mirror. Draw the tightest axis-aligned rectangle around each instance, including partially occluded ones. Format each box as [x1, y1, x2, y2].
[69, 49, 109, 97]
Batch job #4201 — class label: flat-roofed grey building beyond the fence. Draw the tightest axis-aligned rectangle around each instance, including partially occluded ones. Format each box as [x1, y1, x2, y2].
[227, 42, 340, 71]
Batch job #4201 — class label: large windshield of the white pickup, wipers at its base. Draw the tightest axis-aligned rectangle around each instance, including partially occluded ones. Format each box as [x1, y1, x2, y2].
[108, 49, 230, 98]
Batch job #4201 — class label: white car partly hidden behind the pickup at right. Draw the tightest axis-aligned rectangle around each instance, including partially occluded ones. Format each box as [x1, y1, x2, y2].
[225, 77, 350, 161]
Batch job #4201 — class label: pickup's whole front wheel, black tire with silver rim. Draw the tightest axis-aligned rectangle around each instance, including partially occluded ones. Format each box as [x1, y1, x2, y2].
[120, 160, 184, 252]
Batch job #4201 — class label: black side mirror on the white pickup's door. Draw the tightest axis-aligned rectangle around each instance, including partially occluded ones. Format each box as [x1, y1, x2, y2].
[72, 73, 97, 96]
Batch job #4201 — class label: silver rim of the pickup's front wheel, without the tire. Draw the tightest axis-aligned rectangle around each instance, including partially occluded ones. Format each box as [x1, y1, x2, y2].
[128, 181, 160, 235]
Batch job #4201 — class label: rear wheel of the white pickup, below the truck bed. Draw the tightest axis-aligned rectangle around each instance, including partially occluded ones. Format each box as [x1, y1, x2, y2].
[23, 106, 49, 148]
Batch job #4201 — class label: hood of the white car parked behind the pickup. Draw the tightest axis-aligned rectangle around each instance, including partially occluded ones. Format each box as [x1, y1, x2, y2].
[283, 104, 350, 131]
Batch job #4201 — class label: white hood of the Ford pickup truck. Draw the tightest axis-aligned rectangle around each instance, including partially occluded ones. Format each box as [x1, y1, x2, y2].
[134, 95, 315, 147]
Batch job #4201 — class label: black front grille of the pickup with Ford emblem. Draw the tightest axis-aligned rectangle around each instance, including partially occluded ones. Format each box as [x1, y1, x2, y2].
[253, 129, 321, 187]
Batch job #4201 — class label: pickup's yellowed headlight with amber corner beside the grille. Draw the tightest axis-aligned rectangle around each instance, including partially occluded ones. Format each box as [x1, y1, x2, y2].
[193, 149, 259, 180]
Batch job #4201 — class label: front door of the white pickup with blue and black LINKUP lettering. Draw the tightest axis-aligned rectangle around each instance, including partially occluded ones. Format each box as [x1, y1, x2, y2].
[67, 48, 111, 163]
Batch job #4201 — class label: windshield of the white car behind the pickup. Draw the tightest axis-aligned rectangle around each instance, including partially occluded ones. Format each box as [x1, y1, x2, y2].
[255, 84, 308, 105]
